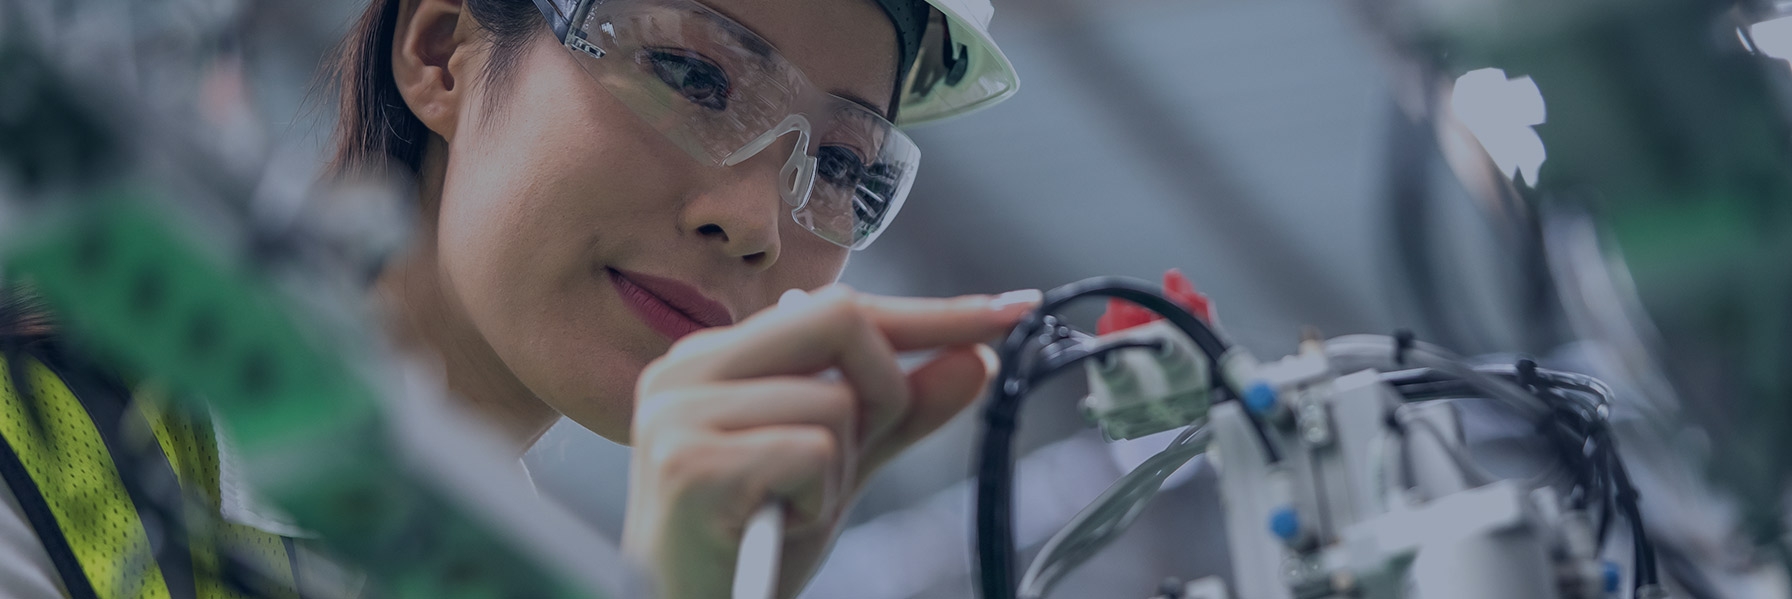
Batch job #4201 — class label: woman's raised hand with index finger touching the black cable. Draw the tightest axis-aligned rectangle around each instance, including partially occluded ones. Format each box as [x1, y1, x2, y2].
[622, 285, 1039, 599]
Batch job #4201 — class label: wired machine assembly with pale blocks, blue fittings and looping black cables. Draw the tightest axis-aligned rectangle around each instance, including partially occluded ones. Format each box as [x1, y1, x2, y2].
[975, 278, 1662, 599]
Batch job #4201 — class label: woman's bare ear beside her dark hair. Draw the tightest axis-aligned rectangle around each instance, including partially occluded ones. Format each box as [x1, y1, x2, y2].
[392, 0, 473, 140]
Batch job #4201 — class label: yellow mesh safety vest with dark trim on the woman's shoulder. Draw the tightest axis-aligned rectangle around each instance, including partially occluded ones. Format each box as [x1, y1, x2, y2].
[0, 348, 303, 599]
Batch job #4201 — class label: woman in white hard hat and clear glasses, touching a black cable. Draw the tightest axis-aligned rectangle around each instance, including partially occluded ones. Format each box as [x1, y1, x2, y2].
[0, 0, 1038, 597]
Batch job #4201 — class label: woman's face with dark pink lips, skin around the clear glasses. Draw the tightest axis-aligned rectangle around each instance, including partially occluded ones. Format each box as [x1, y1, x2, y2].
[435, 0, 896, 441]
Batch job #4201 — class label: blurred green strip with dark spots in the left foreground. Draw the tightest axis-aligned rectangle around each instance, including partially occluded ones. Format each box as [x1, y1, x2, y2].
[0, 192, 602, 599]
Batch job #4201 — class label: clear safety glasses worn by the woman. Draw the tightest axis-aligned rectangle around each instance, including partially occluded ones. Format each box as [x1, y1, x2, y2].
[536, 0, 921, 249]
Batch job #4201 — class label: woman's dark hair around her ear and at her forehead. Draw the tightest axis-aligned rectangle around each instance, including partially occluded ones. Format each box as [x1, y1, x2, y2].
[330, 0, 547, 174]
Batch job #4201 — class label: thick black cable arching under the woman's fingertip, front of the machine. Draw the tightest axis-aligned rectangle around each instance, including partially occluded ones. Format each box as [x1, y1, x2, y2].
[975, 276, 1254, 599]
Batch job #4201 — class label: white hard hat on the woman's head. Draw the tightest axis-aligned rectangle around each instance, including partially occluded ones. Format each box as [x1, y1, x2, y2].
[896, 0, 1020, 126]
